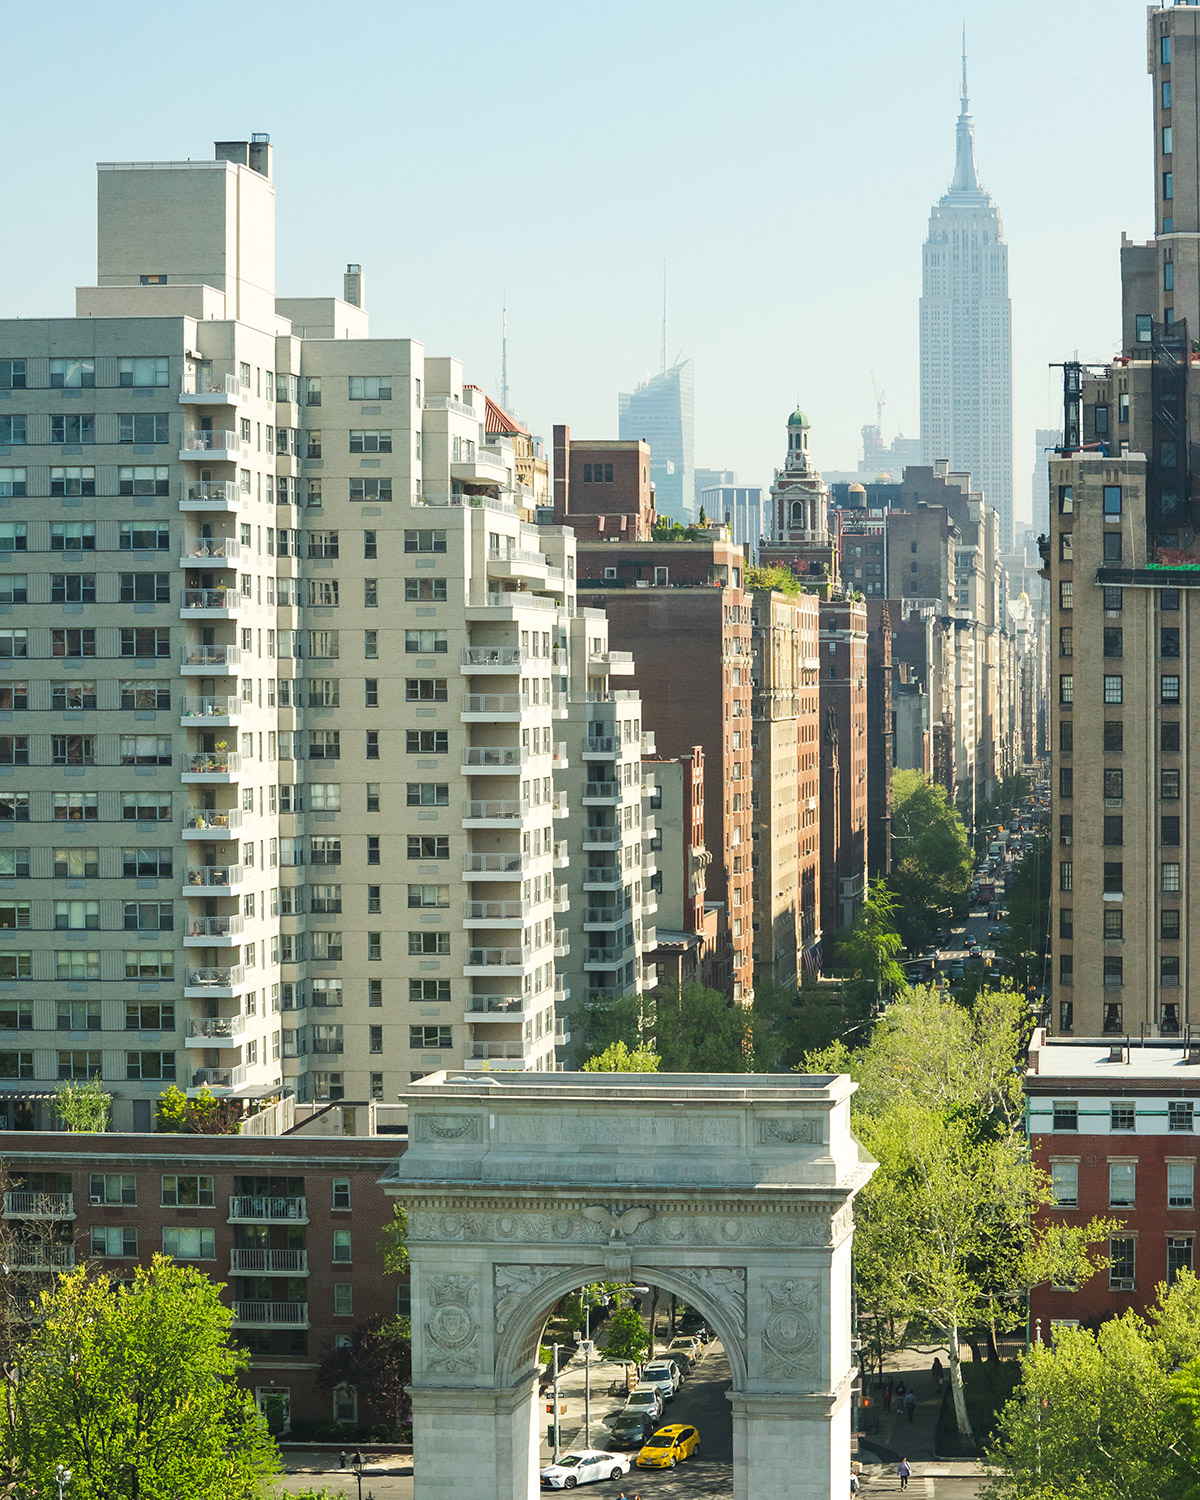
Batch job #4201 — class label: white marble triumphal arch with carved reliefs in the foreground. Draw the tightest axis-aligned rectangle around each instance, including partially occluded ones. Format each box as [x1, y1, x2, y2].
[386, 1073, 875, 1500]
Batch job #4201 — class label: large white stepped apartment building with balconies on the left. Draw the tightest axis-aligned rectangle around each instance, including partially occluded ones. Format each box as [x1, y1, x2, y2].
[0, 137, 653, 1128]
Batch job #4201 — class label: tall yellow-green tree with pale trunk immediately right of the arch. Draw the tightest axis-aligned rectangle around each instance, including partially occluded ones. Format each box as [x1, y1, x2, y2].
[806, 990, 1118, 1439]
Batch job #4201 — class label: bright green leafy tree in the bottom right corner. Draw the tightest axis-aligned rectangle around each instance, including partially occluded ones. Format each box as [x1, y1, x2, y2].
[989, 1272, 1200, 1500]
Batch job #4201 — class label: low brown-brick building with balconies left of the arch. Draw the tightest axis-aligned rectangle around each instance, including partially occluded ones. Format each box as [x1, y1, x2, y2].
[3, 1104, 408, 1427]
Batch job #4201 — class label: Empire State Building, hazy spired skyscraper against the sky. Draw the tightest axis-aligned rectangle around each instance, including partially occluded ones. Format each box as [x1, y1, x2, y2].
[921, 48, 1013, 552]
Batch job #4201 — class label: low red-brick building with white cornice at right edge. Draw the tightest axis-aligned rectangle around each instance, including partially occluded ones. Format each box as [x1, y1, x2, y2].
[1025, 1031, 1200, 1340]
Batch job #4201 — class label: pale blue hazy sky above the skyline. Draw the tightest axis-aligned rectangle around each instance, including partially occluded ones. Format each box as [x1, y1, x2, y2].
[0, 0, 1154, 518]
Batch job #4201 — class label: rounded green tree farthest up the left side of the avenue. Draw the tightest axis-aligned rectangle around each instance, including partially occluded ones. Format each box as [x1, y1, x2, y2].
[888, 771, 972, 953]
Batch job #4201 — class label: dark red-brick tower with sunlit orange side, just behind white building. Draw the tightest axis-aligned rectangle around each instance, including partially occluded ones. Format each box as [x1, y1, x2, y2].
[578, 534, 753, 1001]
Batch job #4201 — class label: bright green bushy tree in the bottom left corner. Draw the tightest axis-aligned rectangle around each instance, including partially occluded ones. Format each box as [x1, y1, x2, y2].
[0, 1256, 279, 1500]
